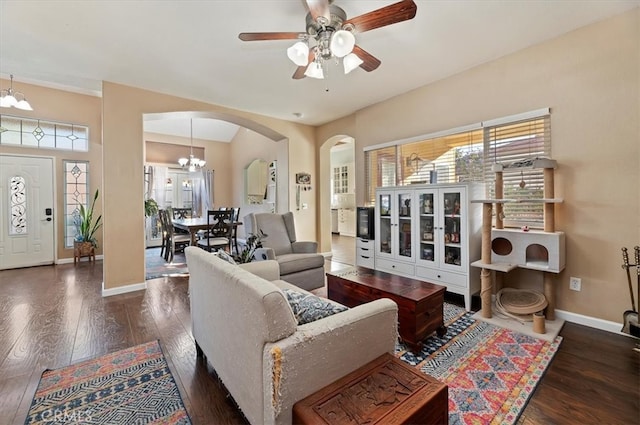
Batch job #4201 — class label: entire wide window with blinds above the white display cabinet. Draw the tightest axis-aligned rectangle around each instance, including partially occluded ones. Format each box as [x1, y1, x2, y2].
[365, 110, 551, 227]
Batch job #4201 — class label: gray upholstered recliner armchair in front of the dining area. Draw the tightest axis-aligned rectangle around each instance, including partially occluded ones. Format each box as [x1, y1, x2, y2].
[243, 212, 324, 291]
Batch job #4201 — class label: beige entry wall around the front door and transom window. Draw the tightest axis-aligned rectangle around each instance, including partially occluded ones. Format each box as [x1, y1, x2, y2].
[0, 80, 103, 260]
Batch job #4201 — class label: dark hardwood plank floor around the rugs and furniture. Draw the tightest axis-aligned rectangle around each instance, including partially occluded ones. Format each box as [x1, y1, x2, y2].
[0, 238, 640, 424]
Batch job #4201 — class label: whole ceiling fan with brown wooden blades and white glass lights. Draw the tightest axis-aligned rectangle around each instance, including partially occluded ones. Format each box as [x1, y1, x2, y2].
[238, 0, 417, 80]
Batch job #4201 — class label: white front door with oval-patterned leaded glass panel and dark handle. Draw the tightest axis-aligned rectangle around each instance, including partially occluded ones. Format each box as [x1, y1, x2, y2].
[0, 155, 55, 270]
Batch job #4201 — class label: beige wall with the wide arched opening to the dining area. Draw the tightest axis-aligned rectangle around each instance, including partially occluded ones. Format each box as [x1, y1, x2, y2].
[102, 82, 315, 290]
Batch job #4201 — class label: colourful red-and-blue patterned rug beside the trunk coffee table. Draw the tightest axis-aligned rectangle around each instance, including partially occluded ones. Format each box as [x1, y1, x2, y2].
[396, 303, 562, 425]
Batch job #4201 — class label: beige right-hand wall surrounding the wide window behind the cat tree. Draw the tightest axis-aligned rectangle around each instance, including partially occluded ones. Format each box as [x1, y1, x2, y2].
[318, 8, 640, 322]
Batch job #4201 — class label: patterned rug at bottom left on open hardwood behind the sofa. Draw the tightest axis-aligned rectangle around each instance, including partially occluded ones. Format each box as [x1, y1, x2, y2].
[25, 341, 191, 425]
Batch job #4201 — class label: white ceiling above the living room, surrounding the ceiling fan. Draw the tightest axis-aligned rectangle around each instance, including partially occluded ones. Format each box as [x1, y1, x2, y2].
[0, 0, 640, 138]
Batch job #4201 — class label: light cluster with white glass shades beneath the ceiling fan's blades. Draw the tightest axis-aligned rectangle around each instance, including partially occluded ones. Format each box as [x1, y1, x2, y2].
[287, 6, 363, 79]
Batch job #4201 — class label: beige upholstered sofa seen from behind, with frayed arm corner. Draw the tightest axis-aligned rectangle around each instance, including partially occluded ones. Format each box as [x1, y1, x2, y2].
[185, 247, 398, 424]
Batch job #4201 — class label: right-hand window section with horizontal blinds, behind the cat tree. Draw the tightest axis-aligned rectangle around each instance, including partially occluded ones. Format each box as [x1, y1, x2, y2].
[484, 116, 551, 227]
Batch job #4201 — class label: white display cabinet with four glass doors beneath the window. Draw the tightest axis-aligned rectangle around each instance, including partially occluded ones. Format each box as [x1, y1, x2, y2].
[375, 183, 483, 310]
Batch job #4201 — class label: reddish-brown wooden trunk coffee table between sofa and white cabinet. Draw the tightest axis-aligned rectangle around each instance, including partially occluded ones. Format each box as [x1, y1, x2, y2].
[327, 267, 447, 351]
